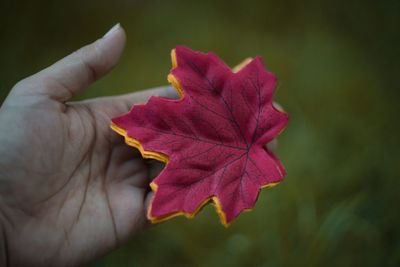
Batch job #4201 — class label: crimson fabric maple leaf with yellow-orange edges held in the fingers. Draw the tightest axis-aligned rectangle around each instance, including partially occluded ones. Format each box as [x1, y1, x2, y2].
[111, 46, 289, 226]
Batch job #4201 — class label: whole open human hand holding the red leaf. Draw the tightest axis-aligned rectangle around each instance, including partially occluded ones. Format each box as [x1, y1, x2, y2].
[0, 26, 178, 266]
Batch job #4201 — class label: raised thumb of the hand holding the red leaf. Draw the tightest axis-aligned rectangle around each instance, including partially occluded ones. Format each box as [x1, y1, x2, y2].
[10, 23, 126, 102]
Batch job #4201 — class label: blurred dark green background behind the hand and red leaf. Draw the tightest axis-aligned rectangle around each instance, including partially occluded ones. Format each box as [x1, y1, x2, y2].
[0, 0, 400, 266]
